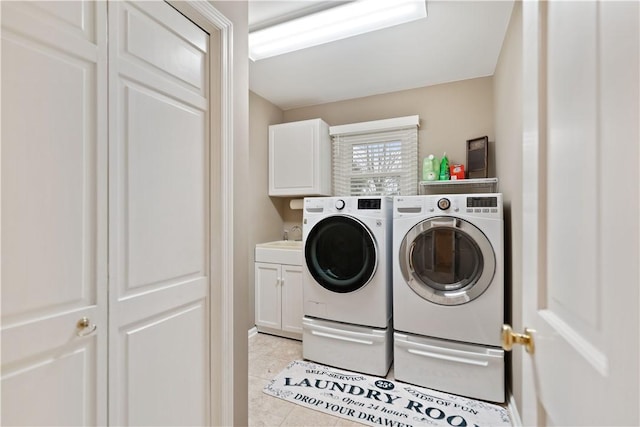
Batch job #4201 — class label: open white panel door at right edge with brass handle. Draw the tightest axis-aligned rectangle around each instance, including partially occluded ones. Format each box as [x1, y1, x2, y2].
[521, 1, 640, 426]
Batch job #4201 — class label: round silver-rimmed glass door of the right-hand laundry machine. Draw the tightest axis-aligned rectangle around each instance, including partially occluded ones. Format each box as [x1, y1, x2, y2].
[398, 217, 496, 305]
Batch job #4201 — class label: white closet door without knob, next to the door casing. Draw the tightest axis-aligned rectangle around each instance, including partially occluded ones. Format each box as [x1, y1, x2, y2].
[109, 1, 210, 426]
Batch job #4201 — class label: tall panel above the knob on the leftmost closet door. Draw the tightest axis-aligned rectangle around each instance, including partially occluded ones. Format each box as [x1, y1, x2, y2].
[2, 40, 99, 322]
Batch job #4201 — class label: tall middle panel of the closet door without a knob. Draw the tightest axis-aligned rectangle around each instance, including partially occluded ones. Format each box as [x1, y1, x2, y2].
[123, 84, 207, 288]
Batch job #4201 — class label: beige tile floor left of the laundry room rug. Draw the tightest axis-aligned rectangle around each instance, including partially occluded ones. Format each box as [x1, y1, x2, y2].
[249, 333, 370, 427]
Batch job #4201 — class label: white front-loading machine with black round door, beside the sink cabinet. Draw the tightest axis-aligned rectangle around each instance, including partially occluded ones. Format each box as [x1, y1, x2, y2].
[302, 196, 393, 375]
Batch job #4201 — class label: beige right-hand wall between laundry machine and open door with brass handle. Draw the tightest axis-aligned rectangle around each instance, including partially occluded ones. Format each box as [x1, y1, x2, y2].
[493, 2, 524, 414]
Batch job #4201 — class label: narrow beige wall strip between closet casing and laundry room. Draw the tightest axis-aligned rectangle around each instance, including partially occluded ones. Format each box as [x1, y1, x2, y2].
[211, 1, 249, 425]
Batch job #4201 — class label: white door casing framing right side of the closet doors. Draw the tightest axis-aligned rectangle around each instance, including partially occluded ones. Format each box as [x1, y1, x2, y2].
[174, 0, 235, 425]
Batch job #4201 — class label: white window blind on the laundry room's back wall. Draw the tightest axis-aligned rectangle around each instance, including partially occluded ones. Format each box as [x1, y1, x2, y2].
[331, 116, 418, 196]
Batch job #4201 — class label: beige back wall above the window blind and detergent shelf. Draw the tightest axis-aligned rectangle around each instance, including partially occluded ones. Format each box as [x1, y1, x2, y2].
[284, 77, 495, 176]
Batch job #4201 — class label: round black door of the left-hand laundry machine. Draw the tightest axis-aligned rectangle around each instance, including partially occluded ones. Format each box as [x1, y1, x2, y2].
[304, 215, 378, 293]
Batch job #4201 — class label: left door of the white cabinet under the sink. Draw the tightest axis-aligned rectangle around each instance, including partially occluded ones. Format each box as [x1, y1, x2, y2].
[255, 262, 281, 329]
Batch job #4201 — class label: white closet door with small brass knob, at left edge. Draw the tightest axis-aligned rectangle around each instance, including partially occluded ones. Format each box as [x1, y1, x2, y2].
[0, 1, 107, 426]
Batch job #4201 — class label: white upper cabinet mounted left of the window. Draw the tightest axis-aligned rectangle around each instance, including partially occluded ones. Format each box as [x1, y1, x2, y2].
[269, 119, 331, 196]
